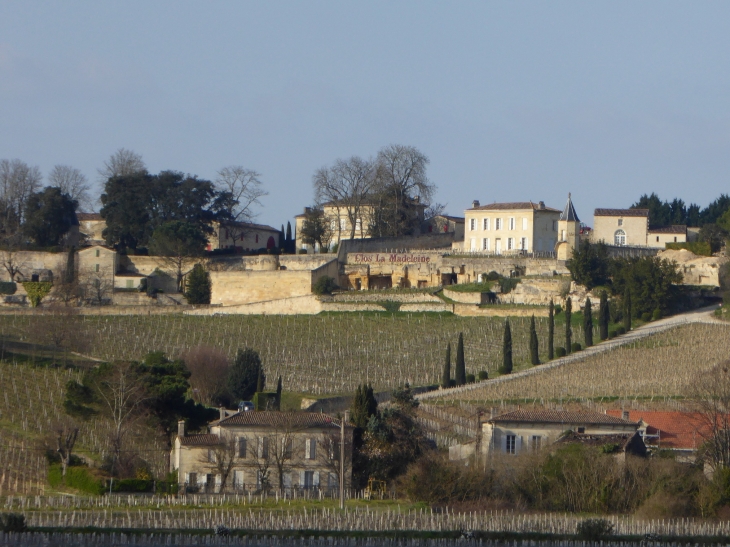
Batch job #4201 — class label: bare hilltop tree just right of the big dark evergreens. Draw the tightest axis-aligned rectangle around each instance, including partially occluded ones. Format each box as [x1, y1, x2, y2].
[215, 165, 268, 247]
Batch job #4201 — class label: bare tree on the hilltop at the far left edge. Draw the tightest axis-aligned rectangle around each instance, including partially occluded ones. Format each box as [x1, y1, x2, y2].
[0, 159, 43, 236]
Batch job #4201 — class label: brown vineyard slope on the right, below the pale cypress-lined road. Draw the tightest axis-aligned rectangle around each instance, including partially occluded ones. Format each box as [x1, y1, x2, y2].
[430, 323, 730, 404]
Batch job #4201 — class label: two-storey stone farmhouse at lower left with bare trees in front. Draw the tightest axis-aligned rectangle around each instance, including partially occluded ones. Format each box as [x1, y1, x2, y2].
[170, 409, 353, 492]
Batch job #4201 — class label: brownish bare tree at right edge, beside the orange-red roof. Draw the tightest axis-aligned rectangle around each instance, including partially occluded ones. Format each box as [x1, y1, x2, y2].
[692, 361, 730, 470]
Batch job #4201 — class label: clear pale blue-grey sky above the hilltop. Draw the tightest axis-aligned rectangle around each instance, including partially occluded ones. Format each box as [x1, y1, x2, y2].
[0, 0, 730, 227]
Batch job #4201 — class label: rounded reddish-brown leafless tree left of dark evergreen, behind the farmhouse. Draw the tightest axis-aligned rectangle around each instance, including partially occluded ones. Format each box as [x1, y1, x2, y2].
[180, 346, 230, 406]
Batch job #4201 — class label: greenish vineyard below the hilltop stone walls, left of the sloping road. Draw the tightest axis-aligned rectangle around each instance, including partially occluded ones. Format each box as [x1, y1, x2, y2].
[0, 314, 597, 395]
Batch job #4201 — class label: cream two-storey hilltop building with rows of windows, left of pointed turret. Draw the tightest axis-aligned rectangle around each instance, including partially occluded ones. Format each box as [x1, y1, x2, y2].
[461, 201, 560, 254]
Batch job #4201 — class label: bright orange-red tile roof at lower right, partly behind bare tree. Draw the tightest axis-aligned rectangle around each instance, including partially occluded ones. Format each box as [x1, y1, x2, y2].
[608, 410, 710, 450]
